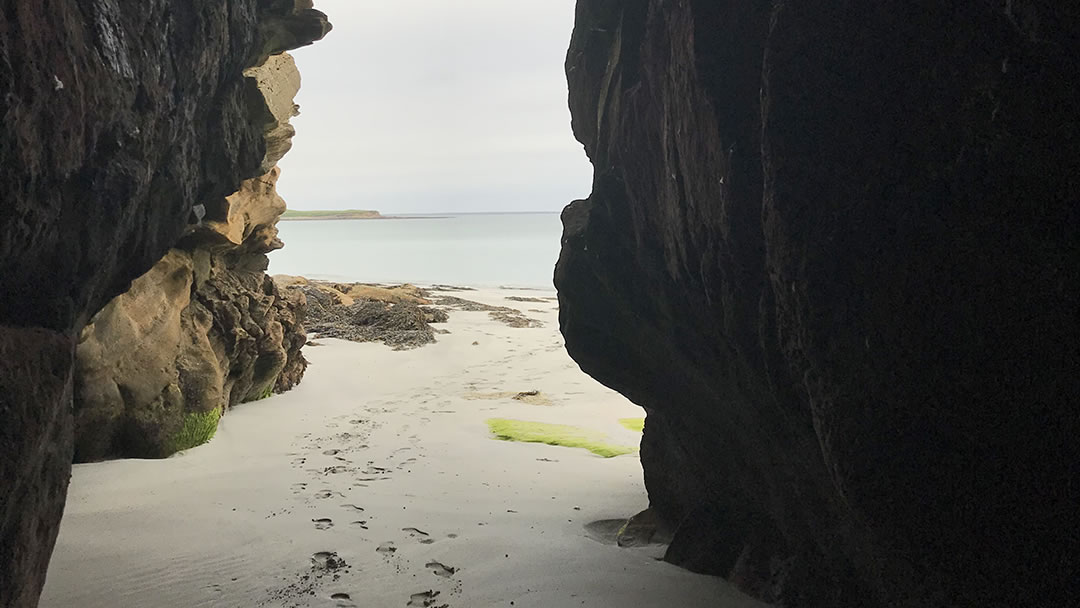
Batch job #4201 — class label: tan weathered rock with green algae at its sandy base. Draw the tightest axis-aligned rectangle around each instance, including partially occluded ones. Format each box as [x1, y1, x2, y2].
[75, 168, 307, 461]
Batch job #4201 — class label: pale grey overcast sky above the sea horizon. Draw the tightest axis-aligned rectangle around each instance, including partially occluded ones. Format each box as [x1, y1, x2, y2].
[278, 0, 592, 213]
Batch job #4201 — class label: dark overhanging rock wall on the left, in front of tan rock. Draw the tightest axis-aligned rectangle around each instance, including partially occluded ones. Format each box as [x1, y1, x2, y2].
[0, 0, 329, 607]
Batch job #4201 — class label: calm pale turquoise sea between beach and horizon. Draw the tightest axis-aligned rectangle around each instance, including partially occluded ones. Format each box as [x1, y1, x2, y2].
[270, 213, 563, 288]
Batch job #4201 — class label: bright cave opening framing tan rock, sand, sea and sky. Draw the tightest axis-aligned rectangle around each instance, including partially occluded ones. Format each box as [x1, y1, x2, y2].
[31, 0, 768, 607]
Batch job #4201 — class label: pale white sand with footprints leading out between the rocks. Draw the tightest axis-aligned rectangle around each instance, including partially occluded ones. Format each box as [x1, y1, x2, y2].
[41, 291, 764, 608]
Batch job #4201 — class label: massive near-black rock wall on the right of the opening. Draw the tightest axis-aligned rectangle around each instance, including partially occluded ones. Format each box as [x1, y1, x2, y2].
[555, 0, 1080, 607]
